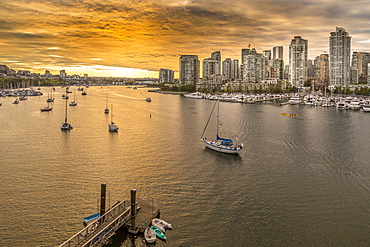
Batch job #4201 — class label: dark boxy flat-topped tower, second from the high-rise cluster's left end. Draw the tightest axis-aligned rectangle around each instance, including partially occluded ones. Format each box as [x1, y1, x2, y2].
[179, 55, 200, 85]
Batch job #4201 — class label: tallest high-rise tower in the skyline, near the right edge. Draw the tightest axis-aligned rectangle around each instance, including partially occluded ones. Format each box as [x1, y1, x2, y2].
[329, 27, 352, 87]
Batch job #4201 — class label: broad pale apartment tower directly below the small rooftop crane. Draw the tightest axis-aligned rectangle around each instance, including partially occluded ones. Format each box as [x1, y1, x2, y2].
[241, 48, 266, 83]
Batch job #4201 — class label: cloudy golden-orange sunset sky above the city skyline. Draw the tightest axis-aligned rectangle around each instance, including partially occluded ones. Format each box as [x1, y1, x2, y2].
[0, 0, 370, 77]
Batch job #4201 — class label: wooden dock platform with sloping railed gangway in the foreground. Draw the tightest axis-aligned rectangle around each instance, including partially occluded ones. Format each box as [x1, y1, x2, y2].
[60, 190, 159, 247]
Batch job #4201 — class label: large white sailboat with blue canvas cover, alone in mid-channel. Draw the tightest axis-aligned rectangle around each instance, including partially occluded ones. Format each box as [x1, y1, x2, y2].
[200, 100, 243, 154]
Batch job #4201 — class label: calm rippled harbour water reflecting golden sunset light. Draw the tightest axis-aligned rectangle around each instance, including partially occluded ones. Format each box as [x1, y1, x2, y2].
[0, 87, 370, 246]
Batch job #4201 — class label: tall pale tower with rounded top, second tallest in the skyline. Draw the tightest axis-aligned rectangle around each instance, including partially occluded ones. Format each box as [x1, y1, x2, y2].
[289, 36, 308, 88]
